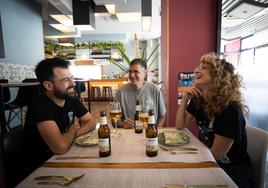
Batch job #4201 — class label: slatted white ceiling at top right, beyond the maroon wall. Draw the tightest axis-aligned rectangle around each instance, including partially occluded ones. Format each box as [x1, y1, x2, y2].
[221, 0, 268, 40]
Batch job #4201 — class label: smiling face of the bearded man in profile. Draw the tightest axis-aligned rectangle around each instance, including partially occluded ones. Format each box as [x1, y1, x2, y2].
[52, 67, 76, 99]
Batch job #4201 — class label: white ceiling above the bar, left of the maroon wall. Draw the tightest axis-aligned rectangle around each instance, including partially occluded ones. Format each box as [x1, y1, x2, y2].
[35, 0, 161, 40]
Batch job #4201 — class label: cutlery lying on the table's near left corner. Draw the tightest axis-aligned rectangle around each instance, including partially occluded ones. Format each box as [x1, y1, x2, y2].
[34, 174, 85, 186]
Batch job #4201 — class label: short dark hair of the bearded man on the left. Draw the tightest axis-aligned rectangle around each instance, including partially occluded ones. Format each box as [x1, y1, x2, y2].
[34, 58, 70, 83]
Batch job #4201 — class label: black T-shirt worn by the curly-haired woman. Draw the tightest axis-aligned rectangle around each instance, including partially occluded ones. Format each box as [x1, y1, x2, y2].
[187, 100, 251, 165]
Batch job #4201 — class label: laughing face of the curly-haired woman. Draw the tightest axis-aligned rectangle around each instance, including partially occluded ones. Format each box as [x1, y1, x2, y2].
[194, 63, 212, 88]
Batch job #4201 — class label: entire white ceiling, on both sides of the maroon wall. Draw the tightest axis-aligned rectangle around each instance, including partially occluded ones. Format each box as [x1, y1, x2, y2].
[35, 0, 268, 40]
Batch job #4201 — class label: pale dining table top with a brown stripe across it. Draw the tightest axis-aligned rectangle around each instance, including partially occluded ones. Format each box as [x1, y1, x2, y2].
[17, 129, 237, 188]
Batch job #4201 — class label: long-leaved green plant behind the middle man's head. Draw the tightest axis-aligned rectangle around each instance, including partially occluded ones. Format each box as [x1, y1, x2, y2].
[110, 44, 160, 72]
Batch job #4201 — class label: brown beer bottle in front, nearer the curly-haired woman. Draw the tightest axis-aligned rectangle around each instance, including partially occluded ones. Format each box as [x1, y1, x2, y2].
[146, 109, 158, 157]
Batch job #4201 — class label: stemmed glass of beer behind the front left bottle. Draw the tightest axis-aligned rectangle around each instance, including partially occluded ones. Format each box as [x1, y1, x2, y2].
[110, 102, 121, 137]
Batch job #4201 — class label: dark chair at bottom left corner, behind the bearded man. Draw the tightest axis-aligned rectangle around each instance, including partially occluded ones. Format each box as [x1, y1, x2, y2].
[0, 127, 34, 188]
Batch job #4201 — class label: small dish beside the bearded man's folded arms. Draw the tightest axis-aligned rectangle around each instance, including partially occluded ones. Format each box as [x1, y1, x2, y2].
[75, 130, 99, 146]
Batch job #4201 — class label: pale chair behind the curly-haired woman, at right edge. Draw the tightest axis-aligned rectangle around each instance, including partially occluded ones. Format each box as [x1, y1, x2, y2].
[246, 125, 268, 188]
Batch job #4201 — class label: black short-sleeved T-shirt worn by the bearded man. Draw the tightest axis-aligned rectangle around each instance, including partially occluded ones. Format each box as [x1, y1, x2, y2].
[25, 95, 88, 163]
